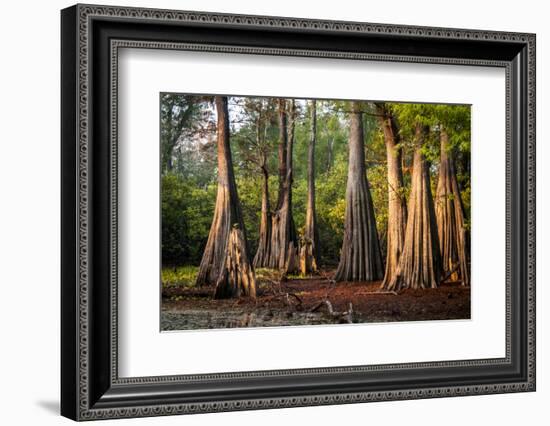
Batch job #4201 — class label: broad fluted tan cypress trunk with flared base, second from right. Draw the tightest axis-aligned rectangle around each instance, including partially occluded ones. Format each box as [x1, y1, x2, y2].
[387, 126, 441, 291]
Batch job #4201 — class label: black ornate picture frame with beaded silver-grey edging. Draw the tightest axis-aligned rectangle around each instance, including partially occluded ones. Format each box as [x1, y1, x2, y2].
[61, 5, 535, 420]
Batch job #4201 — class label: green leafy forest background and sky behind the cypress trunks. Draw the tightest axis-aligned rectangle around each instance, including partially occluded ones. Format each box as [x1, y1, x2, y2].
[160, 93, 470, 269]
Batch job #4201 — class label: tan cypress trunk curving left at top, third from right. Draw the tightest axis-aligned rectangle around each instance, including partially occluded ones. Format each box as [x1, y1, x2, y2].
[375, 104, 407, 288]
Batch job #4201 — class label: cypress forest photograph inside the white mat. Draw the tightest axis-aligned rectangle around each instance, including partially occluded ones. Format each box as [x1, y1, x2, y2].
[159, 93, 474, 331]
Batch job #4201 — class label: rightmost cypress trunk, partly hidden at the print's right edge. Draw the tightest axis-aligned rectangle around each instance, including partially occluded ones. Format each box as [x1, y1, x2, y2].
[436, 129, 470, 286]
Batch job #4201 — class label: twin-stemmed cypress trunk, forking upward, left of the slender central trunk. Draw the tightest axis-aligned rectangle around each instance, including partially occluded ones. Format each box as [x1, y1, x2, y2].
[267, 99, 299, 275]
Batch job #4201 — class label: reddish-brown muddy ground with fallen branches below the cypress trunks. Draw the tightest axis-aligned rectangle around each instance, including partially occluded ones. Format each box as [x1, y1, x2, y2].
[161, 274, 470, 330]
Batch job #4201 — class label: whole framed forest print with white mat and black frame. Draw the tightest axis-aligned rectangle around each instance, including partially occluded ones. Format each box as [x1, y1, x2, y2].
[61, 5, 535, 420]
